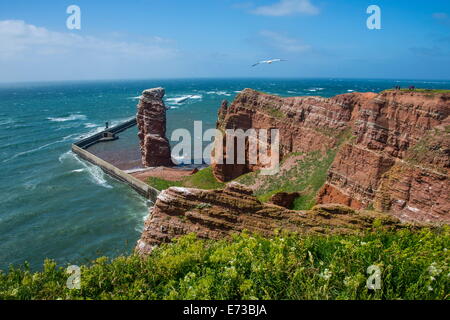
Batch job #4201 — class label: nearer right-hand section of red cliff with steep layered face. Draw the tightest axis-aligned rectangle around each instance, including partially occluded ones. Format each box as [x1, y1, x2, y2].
[318, 91, 450, 223]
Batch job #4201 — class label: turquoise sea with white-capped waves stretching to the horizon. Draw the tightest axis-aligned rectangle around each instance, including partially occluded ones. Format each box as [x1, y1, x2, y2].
[0, 79, 450, 270]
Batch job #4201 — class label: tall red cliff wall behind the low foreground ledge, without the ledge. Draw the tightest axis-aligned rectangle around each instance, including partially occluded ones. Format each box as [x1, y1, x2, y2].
[213, 89, 450, 222]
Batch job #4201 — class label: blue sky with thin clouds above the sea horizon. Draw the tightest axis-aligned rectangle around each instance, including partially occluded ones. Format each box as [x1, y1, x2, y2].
[0, 0, 450, 82]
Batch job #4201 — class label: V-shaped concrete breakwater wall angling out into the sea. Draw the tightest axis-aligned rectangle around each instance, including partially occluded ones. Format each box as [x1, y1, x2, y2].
[72, 119, 159, 202]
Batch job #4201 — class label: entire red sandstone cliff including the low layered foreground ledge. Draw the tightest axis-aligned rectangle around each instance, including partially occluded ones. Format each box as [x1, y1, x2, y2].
[136, 89, 450, 254]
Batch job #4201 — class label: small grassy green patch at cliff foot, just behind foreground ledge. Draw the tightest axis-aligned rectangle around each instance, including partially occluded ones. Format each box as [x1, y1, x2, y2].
[147, 167, 225, 191]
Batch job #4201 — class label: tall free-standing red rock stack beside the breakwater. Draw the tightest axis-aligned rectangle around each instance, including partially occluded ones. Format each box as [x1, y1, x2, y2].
[136, 88, 172, 167]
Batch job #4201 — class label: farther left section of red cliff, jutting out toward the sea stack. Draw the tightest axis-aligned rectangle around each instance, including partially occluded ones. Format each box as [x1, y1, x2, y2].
[212, 89, 366, 181]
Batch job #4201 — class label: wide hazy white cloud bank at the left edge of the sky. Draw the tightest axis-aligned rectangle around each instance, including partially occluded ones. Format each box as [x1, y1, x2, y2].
[0, 20, 176, 60]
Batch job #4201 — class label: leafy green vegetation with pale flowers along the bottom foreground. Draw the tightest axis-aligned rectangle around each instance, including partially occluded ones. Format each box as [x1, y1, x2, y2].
[0, 227, 450, 299]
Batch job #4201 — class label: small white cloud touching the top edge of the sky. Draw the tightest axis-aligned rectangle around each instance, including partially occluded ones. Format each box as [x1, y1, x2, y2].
[251, 0, 319, 17]
